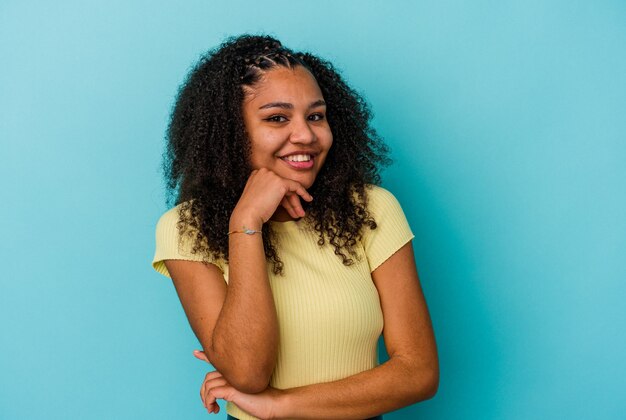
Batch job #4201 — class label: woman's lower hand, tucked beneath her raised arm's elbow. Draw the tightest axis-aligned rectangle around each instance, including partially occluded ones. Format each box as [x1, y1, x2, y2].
[193, 350, 283, 419]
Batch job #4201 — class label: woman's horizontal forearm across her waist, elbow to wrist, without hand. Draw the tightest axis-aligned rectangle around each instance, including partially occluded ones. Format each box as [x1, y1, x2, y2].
[275, 357, 439, 419]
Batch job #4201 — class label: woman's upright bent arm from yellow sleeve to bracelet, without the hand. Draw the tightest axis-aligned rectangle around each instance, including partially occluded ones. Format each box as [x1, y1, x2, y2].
[165, 226, 278, 393]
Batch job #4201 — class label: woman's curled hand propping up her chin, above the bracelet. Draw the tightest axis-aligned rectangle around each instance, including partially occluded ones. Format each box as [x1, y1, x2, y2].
[231, 168, 313, 229]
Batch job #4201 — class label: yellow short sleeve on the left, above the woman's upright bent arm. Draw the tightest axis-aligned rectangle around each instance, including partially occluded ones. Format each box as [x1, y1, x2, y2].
[152, 205, 224, 277]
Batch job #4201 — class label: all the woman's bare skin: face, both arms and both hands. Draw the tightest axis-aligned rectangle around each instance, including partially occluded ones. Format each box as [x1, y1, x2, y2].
[165, 67, 439, 419]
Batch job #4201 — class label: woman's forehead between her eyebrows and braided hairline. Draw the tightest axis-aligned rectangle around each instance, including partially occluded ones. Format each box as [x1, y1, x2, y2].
[244, 66, 323, 105]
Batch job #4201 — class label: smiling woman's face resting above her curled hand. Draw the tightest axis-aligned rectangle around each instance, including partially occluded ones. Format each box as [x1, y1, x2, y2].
[243, 66, 333, 188]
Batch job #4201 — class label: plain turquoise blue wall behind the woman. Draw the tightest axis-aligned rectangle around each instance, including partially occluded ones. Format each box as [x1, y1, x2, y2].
[0, 0, 626, 419]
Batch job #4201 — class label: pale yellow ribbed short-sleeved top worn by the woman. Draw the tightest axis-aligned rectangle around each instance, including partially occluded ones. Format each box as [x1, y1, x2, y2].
[152, 186, 413, 420]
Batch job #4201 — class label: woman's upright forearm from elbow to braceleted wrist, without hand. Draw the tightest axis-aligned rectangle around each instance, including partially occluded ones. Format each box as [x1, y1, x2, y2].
[209, 217, 278, 392]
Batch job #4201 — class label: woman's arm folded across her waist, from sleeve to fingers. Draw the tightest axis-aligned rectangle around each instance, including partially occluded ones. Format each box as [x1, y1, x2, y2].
[209, 243, 439, 419]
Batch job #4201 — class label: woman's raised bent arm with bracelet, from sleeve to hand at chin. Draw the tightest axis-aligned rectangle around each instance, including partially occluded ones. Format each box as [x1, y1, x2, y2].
[165, 170, 311, 393]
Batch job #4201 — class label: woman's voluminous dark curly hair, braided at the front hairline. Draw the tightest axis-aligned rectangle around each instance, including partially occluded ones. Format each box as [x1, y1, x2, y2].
[163, 35, 390, 274]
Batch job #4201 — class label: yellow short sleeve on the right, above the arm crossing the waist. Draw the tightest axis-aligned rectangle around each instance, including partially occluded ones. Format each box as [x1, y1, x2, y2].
[362, 186, 415, 272]
